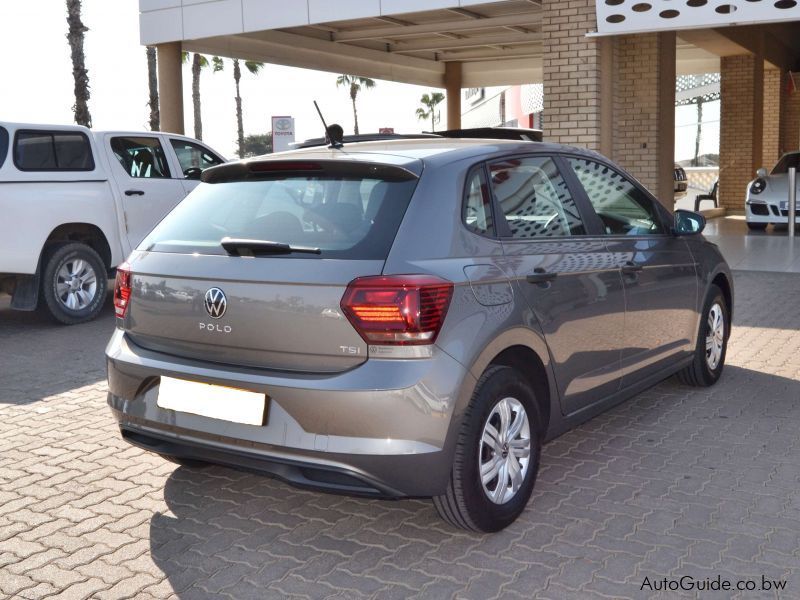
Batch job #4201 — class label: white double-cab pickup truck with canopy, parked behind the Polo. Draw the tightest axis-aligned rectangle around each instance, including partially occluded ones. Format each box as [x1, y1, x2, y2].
[0, 122, 225, 324]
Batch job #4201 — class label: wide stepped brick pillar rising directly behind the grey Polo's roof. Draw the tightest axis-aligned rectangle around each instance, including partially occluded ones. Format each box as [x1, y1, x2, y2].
[542, 0, 675, 208]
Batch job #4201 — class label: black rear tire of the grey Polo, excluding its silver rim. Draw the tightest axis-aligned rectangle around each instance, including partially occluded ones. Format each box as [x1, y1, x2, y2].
[460, 368, 541, 532]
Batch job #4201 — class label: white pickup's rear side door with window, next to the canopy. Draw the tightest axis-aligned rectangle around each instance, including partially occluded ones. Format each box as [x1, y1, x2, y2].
[105, 134, 186, 249]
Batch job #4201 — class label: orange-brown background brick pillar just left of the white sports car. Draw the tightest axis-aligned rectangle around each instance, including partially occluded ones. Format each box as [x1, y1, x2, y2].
[719, 54, 764, 212]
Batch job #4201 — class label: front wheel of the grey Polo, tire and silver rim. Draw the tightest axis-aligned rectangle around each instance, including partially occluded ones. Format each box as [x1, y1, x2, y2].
[678, 285, 730, 387]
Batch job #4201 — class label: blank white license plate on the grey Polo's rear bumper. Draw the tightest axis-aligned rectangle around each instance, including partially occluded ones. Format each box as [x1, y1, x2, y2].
[156, 377, 267, 426]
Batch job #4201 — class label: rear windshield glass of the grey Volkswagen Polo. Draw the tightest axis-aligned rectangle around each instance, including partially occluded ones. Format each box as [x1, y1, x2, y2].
[139, 174, 417, 260]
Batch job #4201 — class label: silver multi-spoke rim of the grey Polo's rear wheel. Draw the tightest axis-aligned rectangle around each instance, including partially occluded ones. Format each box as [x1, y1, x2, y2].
[478, 398, 531, 504]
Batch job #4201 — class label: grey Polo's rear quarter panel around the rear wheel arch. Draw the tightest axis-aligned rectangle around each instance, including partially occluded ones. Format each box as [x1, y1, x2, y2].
[384, 159, 561, 440]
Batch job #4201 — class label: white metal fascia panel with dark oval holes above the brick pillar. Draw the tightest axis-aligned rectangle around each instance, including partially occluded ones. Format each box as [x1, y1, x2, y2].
[597, 0, 800, 33]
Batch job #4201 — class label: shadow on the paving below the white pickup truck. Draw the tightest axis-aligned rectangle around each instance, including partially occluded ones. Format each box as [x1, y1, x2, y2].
[0, 294, 114, 405]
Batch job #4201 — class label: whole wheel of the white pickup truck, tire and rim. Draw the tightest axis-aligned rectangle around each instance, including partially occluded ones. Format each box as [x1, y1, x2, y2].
[42, 242, 108, 325]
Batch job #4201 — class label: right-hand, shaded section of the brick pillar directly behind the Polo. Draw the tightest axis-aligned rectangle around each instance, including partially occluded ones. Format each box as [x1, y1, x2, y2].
[613, 33, 675, 209]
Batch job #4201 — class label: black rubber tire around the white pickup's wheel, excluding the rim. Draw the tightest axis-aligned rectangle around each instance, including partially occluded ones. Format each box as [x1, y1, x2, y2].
[41, 242, 108, 325]
